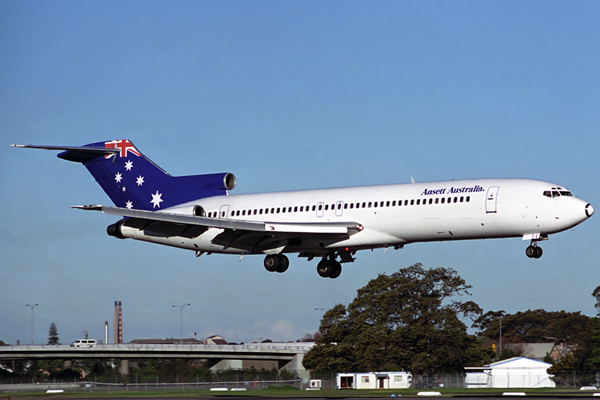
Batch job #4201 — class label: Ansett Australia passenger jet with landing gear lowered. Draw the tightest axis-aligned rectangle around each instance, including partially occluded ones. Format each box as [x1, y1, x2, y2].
[12, 140, 594, 278]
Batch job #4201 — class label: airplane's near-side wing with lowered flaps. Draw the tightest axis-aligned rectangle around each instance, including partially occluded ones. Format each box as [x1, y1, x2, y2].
[73, 205, 363, 251]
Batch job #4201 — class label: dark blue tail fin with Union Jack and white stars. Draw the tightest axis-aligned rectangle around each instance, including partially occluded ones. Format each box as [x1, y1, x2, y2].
[58, 140, 235, 211]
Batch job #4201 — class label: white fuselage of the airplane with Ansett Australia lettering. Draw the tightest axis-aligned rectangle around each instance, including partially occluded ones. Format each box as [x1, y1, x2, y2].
[123, 179, 593, 254]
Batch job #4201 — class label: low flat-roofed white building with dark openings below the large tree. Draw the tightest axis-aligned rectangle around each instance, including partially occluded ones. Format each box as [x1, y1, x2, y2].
[336, 372, 412, 389]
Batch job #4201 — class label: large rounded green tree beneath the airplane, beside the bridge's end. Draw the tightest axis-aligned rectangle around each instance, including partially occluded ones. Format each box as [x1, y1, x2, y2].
[303, 264, 491, 373]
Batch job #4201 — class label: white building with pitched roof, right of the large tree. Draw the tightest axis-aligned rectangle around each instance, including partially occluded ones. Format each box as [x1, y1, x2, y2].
[465, 357, 556, 388]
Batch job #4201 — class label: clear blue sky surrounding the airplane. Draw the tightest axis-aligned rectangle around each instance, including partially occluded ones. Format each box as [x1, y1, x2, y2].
[0, 0, 600, 344]
